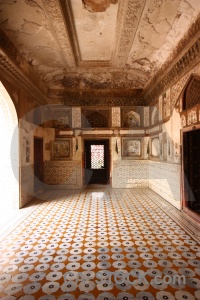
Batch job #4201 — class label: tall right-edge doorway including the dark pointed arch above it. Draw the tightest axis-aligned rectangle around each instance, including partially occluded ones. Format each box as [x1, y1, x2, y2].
[180, 74, 200, 220]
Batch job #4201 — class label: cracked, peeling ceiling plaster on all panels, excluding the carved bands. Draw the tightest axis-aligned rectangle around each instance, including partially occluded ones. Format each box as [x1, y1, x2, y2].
[0, 0, 200, 89]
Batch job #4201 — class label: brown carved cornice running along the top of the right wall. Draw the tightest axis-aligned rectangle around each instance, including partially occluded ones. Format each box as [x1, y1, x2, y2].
[144, 15, 200, 105]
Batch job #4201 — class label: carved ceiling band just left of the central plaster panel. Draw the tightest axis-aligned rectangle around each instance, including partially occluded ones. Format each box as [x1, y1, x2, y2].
[43, 0, 76, 69]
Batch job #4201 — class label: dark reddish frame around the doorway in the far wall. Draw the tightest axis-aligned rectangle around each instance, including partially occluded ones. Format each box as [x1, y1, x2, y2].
[82, 137, 111, 184]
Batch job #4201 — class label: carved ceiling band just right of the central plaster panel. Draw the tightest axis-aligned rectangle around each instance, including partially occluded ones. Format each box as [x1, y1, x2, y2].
[113, 0, 146, 68]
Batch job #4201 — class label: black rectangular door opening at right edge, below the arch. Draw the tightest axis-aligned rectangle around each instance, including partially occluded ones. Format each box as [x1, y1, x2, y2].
[183, 129, 200, 214]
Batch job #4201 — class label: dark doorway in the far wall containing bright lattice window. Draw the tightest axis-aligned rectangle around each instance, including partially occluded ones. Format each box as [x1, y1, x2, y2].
[84, 139, 110, 184]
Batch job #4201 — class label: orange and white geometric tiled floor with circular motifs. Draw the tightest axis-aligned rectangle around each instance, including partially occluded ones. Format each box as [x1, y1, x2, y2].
[0, 189, 200, 300]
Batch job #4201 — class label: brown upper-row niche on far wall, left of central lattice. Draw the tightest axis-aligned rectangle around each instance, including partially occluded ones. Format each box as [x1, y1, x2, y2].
[54, 108, 71, 129]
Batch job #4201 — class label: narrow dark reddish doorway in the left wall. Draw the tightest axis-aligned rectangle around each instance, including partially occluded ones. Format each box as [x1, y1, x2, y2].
[34, 137, 44, 192]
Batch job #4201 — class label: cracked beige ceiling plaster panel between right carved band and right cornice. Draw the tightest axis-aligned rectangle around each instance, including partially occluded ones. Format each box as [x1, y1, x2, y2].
[127, 0, 200, 82]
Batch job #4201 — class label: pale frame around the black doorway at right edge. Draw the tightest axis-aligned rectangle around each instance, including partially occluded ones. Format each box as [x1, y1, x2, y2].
[181, 124, 200, 222]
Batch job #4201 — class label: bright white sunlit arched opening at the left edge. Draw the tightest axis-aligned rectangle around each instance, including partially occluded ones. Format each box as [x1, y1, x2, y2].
[0, 82, 19, 222]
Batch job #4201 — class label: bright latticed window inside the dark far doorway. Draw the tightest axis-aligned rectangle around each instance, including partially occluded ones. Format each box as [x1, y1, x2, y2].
[91, 145, 104, 169]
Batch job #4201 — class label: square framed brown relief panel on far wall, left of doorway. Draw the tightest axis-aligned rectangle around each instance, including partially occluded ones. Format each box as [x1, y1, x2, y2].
[51, 138, 72, 160]
